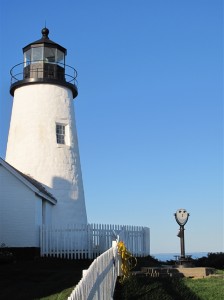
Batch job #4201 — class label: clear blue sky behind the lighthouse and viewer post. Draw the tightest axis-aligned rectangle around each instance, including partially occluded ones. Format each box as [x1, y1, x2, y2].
[0, 0, 224, 253]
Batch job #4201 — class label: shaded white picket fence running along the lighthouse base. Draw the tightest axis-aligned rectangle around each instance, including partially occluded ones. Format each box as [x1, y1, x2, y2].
[40, 224, 150, 259]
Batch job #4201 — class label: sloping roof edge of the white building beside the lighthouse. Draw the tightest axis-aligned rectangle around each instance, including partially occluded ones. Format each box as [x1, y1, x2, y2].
[0, 157, 57, 204]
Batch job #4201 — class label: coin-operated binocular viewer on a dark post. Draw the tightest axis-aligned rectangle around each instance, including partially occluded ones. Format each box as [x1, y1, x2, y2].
[174, 208, 190, 265]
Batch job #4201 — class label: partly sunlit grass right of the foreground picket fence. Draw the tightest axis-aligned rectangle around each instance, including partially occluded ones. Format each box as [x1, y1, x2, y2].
[114, 270, 224, 300]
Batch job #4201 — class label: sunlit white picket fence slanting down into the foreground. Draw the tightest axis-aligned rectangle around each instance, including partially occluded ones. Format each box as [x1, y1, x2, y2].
[68, 242, 119, 300]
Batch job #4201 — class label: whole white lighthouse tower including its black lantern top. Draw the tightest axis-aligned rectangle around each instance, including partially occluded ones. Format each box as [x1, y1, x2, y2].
[6, 28, 87, 226]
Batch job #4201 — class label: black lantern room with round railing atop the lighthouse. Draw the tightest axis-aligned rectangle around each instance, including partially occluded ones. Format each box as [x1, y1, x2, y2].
[10, 27, 78, 98]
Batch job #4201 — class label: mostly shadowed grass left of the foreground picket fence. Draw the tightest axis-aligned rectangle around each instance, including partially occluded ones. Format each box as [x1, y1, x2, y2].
[0, 259, 91, 300]
